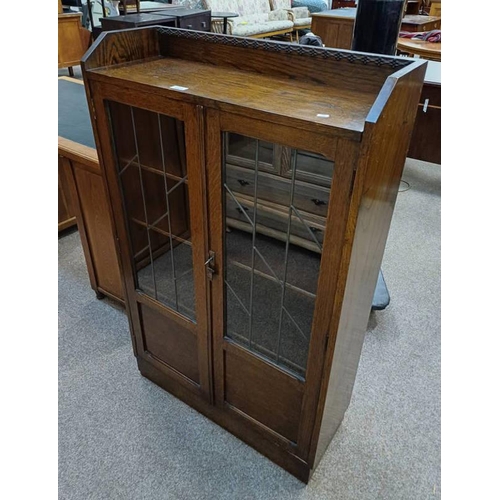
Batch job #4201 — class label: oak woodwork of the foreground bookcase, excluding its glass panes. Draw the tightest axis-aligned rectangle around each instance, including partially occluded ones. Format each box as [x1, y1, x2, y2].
[83, 28, 425, 482]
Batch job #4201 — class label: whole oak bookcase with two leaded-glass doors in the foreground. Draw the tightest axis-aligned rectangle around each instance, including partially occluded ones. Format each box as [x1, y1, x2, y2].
[83, 27, 426, 482]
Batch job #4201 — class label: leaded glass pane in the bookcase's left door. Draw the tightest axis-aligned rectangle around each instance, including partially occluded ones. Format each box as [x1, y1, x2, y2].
[108, 101, 196, 321]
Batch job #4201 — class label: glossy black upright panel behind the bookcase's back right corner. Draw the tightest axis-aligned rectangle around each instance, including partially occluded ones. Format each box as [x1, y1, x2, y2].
[352, 0, 405, 56]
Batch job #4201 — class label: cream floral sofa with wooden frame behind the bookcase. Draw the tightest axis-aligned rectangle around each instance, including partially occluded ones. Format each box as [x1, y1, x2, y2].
[202, 0, 294, 38]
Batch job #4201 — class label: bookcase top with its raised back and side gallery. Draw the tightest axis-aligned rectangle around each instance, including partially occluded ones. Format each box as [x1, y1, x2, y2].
[82, 26, 423, 140]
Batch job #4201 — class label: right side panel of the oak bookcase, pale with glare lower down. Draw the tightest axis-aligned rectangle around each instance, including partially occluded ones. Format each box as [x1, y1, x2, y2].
[310, 63, 426, 466]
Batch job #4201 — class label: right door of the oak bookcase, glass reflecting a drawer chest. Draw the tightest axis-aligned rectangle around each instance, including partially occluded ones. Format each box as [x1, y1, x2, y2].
[206, 110, 353, 460]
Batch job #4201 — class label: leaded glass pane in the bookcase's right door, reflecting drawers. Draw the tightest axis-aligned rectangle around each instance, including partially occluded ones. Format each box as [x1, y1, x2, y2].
[223, 133, 333, 378]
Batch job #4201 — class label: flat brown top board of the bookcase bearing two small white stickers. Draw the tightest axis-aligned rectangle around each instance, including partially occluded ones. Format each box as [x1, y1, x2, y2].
[95, 57, 376, 132]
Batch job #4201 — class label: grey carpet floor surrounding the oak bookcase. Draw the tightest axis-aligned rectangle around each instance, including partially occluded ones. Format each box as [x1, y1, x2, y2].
[59, 160, 441, 500]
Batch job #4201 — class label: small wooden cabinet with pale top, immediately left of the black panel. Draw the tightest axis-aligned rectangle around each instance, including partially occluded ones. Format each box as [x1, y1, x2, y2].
[311, 8, 356, 50]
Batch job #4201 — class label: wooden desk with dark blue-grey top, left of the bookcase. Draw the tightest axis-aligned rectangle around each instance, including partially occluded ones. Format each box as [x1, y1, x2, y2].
[58, 77, 124, 304]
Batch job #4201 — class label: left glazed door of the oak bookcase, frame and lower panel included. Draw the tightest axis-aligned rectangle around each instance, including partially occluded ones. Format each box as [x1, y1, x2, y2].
[94, 84, 211, 399]
